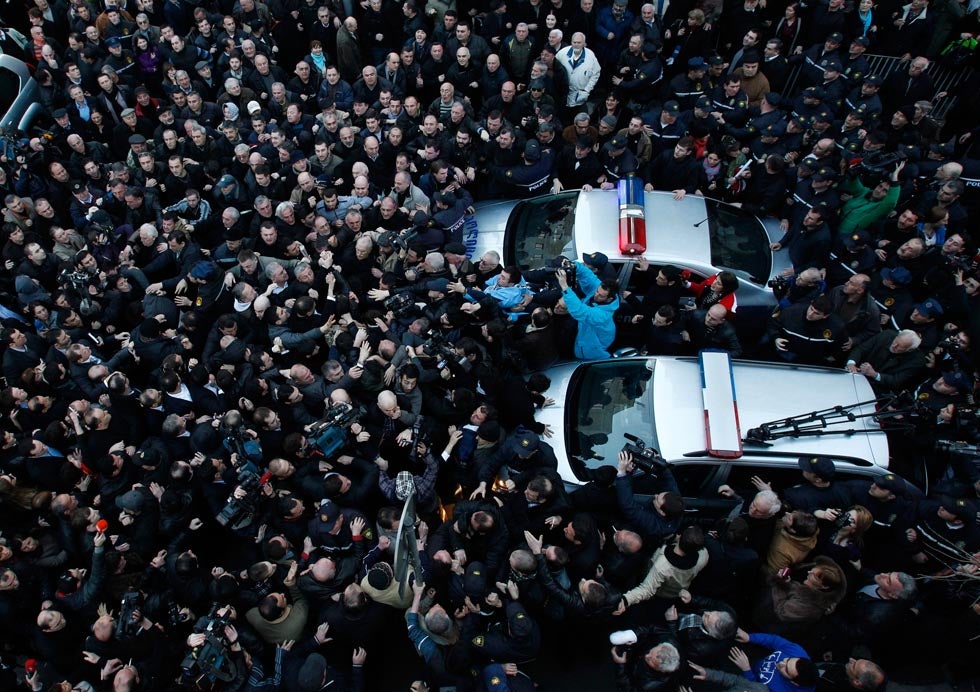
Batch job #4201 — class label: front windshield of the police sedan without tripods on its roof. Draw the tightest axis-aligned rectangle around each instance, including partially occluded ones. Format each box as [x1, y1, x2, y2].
[504, 190, 578, 269]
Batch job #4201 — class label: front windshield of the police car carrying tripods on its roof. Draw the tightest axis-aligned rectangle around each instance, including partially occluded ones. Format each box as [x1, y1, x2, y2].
[565, 358, 659, 478]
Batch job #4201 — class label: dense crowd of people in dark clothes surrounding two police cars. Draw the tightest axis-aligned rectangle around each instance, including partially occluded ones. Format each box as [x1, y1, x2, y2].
[0, 0, 980, 692]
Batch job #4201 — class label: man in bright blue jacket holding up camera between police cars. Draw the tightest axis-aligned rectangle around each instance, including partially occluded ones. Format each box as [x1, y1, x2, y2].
[555, 262, 619, 360]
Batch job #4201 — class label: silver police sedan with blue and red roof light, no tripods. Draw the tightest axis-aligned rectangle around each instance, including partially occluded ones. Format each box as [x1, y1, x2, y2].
[465, 184, 789, 332]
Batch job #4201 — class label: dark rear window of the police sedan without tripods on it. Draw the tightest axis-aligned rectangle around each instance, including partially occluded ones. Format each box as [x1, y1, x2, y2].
[704, 199, 772, 285]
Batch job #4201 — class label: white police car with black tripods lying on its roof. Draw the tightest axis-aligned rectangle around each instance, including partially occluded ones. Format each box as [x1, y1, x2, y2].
[537, 351, 912, 516]
